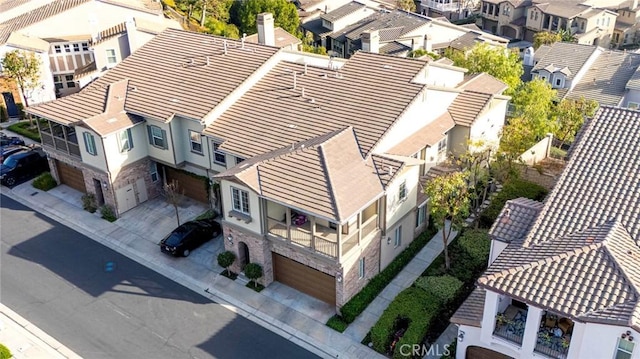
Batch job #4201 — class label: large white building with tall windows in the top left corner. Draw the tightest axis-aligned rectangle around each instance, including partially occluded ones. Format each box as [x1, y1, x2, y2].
[0, 0, 179, 112]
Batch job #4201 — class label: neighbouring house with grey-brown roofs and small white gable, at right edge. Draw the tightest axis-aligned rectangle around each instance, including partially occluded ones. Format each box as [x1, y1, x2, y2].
[524, 42, 640, 108]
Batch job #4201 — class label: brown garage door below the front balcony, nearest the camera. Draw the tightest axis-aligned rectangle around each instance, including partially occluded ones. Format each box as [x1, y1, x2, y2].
[273, 253, 336, 305]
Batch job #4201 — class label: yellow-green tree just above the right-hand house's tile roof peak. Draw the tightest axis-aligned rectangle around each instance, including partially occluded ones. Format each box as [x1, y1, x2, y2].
[554, 97, 598, 148]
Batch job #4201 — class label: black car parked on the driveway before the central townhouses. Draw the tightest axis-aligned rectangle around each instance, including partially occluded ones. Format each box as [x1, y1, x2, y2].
[160, 219, 222, 257]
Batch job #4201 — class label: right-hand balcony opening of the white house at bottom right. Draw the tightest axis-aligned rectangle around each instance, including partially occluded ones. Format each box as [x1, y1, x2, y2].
[534, 312, 573, 359]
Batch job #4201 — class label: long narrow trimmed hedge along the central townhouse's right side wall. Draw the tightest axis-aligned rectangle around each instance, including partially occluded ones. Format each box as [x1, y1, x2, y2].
[340, 227, 436, 324]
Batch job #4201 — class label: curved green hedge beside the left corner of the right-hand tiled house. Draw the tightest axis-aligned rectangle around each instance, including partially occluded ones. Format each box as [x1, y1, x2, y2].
[479, 179, 549, 228]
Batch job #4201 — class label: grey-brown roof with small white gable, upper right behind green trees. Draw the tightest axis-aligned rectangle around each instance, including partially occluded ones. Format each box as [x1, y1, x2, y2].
[531, 42, 598, 79]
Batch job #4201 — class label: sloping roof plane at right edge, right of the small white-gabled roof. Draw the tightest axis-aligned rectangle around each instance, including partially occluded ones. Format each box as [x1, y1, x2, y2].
[565, 50, 640, 106]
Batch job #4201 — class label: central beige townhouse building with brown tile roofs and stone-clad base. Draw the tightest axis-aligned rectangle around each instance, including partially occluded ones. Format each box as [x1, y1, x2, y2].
[28, 26, 509, 308]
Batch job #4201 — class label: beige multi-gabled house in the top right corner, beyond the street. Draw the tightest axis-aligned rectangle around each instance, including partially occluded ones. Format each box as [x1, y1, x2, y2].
[480, 0, 620, 47]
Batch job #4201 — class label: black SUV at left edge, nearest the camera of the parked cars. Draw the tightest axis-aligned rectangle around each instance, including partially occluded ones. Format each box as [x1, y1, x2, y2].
[0, 148, 49, 187]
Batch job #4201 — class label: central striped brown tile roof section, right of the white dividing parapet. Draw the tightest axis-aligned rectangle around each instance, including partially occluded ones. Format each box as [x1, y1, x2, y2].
[204, 52, 427, 158]
